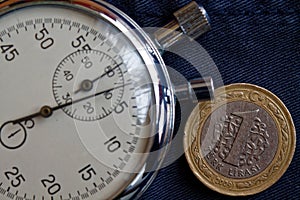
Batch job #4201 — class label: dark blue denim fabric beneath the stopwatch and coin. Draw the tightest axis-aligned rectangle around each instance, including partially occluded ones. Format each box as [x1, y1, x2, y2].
[108, 0, 300, 200]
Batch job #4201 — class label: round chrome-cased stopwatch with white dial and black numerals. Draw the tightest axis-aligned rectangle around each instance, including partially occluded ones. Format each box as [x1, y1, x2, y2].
[0, 0, 208, 200]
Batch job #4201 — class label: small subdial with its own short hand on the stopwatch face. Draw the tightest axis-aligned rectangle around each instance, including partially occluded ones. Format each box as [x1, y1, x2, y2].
[52, 50, 124, 121]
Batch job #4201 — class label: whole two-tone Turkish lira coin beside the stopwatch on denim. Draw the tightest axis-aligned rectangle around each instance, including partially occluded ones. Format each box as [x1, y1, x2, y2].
[184, 83, 296, 196]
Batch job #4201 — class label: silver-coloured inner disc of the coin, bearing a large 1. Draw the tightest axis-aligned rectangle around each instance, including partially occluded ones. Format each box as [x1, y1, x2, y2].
[200, 101, 279, 179]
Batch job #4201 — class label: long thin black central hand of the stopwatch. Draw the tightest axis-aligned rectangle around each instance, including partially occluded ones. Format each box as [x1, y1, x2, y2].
[12, 83, 131, 124]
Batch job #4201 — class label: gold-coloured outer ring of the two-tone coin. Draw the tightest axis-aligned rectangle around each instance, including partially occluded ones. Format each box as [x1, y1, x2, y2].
[184, 83, 296, 196]
